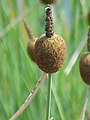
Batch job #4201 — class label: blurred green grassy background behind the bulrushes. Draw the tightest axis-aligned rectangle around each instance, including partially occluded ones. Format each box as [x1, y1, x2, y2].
[0, 0, 90, 120]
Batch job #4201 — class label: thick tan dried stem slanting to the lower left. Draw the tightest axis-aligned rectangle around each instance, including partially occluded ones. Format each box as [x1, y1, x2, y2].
[9, 73, 47, 120]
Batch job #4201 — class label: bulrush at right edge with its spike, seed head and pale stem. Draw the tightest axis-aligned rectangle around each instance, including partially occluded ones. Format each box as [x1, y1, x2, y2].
[79, 28, 90, 120]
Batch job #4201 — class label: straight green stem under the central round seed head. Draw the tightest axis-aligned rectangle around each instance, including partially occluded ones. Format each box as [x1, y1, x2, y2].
[46, 74, 52, 120]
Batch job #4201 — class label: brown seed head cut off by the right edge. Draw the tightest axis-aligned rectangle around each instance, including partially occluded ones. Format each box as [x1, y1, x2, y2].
[79, 53, 90, 85]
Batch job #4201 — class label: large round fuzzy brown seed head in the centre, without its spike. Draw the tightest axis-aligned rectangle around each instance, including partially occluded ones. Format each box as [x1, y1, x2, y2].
[35, 34, 66, 73]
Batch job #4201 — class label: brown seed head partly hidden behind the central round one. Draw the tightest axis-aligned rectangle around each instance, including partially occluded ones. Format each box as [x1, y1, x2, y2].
[27, 41, 35, 62]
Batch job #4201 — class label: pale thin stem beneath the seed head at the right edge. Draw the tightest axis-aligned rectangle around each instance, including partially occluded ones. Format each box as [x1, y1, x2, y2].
[80, 86, 90, 120]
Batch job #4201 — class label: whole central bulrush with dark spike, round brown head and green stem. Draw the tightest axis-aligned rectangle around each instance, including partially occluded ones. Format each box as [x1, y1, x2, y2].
[35, 5, 66, 120]
